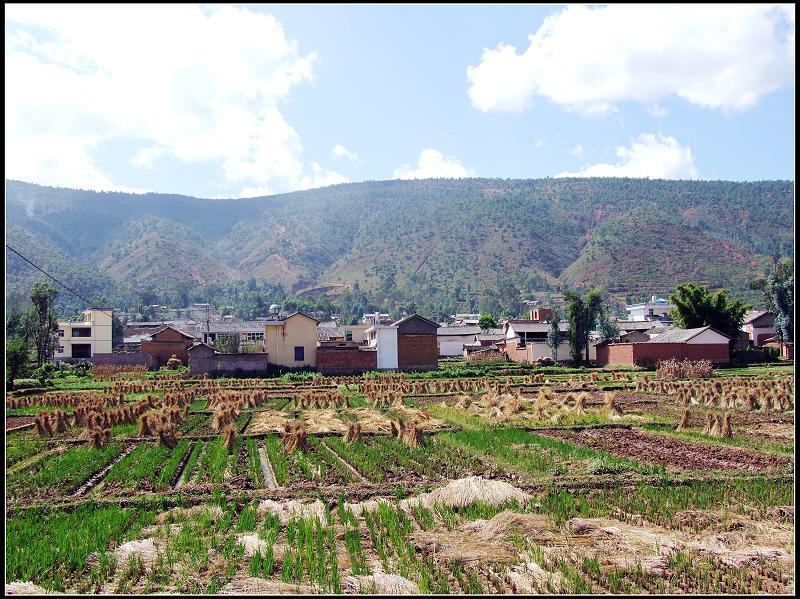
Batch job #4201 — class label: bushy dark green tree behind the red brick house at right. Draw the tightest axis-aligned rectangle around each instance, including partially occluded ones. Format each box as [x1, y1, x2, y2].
[669, 283, 750, 342]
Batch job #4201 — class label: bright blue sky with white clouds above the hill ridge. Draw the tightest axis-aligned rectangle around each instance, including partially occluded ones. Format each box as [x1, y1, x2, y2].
[5, 4, 795, 198]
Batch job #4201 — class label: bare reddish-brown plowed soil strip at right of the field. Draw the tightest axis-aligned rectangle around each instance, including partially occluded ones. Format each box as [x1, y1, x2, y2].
[540, 428, 789, 472]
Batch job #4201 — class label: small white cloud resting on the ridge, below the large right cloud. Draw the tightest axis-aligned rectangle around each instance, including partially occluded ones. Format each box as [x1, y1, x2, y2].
[556, 133, 697, 179]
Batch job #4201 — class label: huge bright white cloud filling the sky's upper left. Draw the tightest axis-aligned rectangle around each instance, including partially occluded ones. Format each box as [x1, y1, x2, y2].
[6, 4, 344, 190]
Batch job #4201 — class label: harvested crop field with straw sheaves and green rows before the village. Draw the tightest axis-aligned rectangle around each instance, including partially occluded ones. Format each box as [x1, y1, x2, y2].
[5, 360, 795, 594]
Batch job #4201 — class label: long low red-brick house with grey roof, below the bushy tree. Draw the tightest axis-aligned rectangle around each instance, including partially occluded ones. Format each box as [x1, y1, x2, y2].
[597, 327, 731, 366]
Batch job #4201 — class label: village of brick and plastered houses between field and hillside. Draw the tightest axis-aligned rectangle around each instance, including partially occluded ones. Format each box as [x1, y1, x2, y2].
[54, 295, 793, 376]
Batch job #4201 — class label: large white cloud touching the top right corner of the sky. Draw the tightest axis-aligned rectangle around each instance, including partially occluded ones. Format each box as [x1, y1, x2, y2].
[467, 4, 794, 115]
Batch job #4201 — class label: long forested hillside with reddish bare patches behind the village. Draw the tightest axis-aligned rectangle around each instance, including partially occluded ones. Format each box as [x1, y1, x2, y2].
[6, 179, 794, 318]
